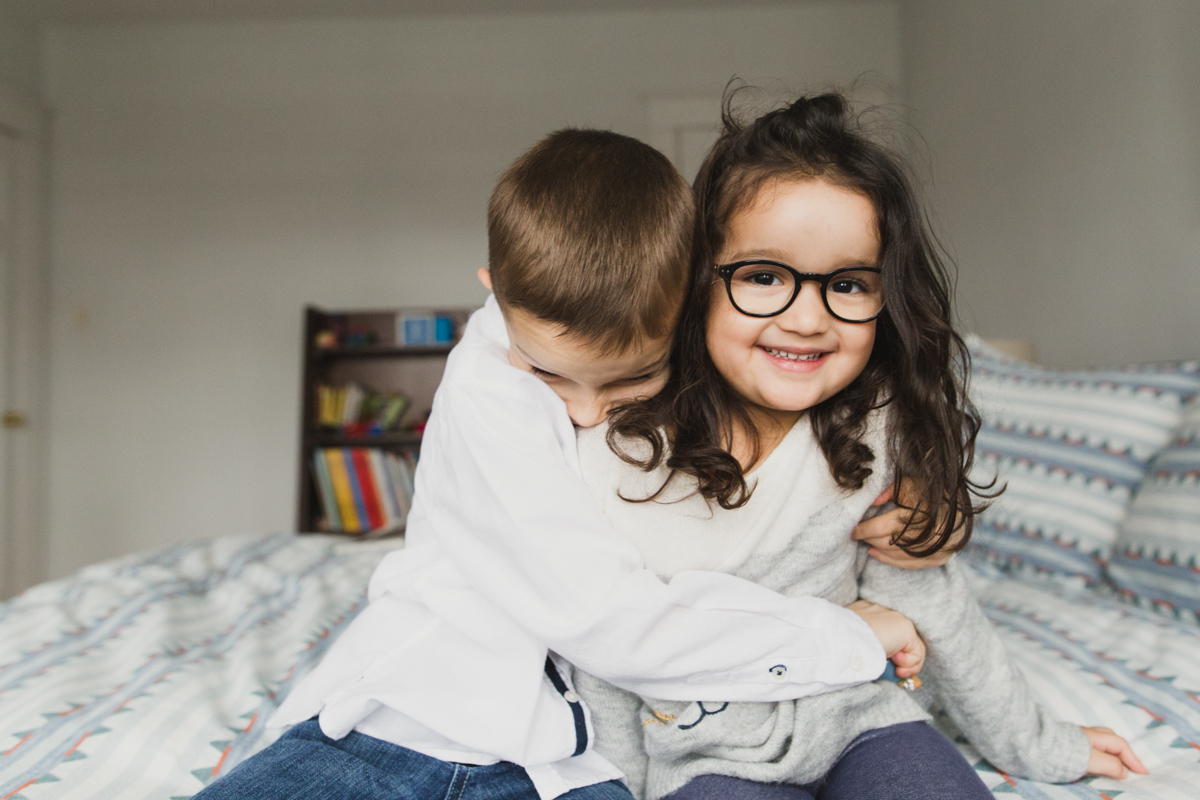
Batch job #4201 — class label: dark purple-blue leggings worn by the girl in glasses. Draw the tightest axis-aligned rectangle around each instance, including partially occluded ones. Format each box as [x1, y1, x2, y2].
[665, 722, 992, 800]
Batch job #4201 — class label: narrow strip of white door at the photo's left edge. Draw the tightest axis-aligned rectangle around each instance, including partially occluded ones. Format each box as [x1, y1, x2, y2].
[0, 128, 17, 599]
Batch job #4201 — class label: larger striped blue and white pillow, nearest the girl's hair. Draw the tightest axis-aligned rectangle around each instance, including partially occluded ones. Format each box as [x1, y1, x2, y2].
[967, 336, 1200, 583]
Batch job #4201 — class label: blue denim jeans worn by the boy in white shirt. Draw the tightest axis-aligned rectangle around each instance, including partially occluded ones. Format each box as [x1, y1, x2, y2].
[193, 720, 634, 800]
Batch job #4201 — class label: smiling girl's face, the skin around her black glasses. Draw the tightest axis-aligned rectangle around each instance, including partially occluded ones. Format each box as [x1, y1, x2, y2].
[708, 179, 880, 427]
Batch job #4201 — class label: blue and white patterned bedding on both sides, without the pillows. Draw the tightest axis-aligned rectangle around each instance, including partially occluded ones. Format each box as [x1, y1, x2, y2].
[0, 535, 1200, 800]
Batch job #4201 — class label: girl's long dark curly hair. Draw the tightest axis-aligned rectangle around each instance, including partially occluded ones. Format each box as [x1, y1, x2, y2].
[608, 91, 994, 557]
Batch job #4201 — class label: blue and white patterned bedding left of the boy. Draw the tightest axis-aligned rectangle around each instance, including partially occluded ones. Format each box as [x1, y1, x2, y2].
[0, 535, 398, 800]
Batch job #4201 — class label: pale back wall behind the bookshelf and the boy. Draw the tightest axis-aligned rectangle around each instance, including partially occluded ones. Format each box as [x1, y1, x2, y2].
[44, 2, 900, 576]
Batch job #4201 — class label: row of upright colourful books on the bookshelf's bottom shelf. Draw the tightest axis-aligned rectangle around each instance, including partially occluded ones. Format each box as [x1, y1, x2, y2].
[312, 447, 416, 535]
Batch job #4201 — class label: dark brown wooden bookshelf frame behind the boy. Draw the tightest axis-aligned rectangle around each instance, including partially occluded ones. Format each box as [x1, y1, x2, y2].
[296, 306, 470, 533]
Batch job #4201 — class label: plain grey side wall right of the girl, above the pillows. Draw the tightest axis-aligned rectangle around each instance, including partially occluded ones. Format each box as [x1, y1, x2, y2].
[901, 0, 1200, 365]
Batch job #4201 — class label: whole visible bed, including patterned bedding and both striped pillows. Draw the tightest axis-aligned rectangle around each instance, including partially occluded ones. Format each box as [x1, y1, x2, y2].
[0, 341, 1200, 800]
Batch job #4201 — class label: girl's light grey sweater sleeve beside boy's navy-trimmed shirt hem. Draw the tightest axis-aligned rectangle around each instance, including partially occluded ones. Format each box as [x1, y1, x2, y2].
[574, 669, 649, 800]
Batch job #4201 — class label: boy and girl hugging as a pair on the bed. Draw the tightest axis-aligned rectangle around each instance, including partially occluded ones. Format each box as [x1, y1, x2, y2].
[197, 94, 1145, 800]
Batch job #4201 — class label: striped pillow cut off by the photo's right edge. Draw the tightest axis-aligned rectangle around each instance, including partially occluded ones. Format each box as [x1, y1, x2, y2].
[1108, 399, 1200, 618]
